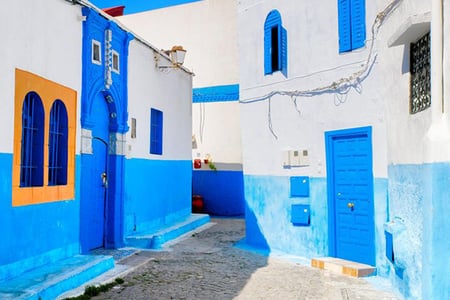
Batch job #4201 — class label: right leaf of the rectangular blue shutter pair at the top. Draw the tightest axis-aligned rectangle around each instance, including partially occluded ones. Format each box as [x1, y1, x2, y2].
[350, 0, 366, 50]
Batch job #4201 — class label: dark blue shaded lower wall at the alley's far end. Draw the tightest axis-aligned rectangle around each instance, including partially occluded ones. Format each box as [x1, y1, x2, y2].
[192, 170, 245, 216]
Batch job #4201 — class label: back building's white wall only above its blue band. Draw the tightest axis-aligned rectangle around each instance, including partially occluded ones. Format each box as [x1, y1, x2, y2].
[118, 0, 239, 87]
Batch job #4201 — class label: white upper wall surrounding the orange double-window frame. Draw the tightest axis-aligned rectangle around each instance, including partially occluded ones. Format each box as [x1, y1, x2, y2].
[0, 0, 82, 153]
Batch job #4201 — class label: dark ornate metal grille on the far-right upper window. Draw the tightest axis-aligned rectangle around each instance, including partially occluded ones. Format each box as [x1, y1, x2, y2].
[410, 33, 431, 114]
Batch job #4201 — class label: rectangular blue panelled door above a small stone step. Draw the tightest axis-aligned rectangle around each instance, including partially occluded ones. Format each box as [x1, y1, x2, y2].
[326, 127, 375, 265]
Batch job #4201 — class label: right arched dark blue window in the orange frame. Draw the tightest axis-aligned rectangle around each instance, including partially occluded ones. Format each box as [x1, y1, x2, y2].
[48, 100, 68, 185]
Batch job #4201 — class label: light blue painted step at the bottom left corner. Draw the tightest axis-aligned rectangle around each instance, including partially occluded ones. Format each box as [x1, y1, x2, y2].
[0, 255, 114, 300]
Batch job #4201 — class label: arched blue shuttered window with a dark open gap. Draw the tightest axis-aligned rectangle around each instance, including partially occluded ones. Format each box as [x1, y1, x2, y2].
[264, 10, 287, 77]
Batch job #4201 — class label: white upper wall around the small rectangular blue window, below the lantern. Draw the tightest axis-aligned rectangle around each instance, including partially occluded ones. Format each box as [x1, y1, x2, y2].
[126, 40, 192, 160]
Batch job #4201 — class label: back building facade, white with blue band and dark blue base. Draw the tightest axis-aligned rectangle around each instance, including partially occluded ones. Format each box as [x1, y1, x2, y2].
[114, 0, 244, 215]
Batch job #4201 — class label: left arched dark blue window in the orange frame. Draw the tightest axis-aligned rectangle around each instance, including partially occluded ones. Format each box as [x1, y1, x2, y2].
[20, 92, 45, 187]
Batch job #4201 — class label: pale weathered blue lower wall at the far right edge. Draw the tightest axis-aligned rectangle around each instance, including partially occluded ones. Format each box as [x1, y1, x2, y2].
[388, 163, 450, 299]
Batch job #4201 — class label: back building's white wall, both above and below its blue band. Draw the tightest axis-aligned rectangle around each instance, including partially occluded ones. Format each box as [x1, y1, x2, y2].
[119, 0, 242, 169]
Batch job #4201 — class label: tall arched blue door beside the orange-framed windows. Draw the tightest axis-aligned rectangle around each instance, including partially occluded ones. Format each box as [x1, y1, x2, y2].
[80, 93, 109, 253]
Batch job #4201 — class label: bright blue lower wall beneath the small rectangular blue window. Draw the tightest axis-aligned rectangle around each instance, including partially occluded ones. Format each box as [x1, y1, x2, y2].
[124, 159, 192, 237]
